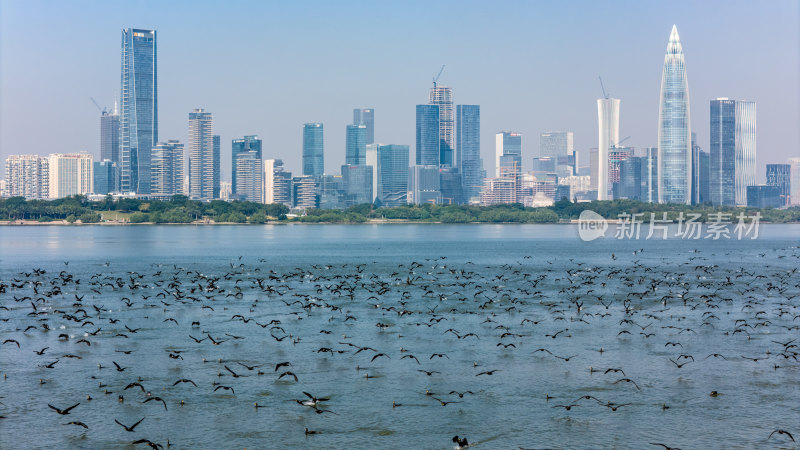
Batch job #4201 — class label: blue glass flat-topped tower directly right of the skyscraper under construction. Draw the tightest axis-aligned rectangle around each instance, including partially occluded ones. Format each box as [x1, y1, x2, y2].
[456, 105, 483, 202]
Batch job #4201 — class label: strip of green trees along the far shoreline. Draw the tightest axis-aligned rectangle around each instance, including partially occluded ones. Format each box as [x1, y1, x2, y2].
[0, 195, 800, 226]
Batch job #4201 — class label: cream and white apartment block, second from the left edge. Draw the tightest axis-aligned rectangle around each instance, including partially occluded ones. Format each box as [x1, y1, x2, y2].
[48, 153, 94, 198]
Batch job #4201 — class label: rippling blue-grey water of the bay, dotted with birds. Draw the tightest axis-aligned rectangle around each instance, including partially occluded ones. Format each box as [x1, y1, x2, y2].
[0, 225, 800, 449]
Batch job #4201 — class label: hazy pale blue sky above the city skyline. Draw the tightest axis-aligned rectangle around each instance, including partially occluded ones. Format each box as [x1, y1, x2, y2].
[0, 0, 800, 182]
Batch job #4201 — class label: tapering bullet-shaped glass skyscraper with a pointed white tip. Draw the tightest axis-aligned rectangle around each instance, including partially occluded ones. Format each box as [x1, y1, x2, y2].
[658, 25, 692, 204]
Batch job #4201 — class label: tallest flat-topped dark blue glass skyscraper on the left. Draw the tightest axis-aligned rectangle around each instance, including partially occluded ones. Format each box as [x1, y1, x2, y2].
[119, 28, 158, 194]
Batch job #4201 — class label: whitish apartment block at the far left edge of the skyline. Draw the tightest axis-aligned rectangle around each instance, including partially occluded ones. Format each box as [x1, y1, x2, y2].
[6, 155, 50, 200]
